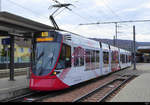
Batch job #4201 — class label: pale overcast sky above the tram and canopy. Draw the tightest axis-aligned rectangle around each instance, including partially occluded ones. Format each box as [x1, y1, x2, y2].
[2, 0, 150, 42]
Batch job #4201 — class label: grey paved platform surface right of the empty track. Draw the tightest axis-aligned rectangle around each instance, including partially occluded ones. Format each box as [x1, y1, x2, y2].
[110, 63, 150, 102]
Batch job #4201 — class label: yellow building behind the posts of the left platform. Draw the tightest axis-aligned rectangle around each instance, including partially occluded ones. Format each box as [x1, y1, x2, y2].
[0, 36, 31, 69]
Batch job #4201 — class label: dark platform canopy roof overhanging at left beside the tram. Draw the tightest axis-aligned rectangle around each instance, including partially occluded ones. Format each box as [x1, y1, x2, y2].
[0, 12, 54, 37]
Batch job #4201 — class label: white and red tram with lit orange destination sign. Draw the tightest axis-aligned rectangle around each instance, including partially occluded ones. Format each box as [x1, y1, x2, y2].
[29, 31, 131, 91]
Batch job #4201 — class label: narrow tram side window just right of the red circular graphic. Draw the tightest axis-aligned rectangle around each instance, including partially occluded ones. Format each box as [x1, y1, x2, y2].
[85, 50, 91, 70]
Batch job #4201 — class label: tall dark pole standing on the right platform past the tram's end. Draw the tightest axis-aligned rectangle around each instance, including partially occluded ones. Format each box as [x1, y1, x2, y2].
[133, 26, 136, 70]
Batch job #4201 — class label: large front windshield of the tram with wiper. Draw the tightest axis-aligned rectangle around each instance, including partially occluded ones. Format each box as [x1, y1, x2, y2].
[32, 31, 61, 76]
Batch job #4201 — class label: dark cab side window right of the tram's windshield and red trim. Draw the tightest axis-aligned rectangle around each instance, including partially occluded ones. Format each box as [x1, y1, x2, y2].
[56, 44, 71, 70]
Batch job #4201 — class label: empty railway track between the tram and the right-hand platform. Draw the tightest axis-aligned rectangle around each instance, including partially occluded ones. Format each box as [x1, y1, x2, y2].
[73, 75, 136, 102]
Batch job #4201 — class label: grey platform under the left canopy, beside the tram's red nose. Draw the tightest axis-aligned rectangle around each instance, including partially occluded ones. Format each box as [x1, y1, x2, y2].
[0, 75, 30, 101]
